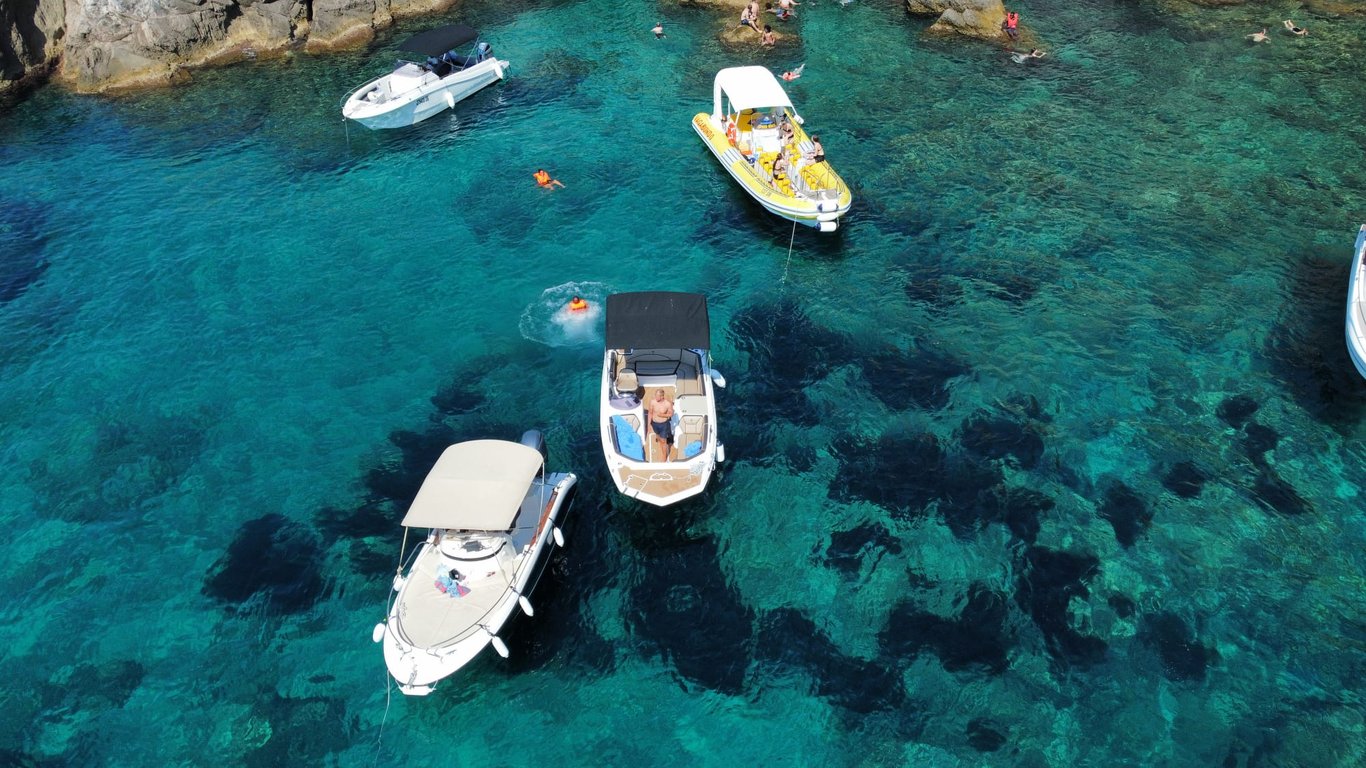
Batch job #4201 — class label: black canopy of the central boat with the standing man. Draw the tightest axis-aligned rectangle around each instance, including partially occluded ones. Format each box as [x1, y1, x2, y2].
[607, 291, 712, 350]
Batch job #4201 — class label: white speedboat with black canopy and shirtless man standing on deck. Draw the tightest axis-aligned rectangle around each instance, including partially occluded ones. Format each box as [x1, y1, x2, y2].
[600, 291, 725, 507]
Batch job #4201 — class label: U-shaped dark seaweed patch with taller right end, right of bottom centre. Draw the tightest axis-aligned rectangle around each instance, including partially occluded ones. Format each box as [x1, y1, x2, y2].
[878, 584, 1012, 675]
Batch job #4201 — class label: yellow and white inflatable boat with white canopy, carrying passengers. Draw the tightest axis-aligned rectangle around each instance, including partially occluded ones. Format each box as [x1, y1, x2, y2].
[693, 67, 852, 232]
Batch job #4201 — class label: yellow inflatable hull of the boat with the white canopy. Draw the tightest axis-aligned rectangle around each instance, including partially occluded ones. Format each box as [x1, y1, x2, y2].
[693, 112, 854, 232]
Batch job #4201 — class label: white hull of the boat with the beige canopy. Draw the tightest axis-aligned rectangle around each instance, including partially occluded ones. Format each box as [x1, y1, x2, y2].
[380, 473, 578, 696]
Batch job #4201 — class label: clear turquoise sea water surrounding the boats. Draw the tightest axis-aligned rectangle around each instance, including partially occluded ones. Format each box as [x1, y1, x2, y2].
[0, 0, 1366, 767]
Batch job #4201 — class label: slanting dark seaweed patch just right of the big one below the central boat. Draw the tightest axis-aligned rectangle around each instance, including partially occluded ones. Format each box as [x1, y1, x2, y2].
[755, 608, 906, 715]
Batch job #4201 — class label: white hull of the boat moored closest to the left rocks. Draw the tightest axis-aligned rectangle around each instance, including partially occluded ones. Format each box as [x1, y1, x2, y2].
[342, 59, 508, 130]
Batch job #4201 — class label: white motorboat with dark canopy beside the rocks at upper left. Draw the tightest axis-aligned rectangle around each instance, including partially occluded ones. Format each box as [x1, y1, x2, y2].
[342, 25, 508, 128]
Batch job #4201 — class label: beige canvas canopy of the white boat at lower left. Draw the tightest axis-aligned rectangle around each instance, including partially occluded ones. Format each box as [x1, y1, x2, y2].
[403, 440, 541, 530]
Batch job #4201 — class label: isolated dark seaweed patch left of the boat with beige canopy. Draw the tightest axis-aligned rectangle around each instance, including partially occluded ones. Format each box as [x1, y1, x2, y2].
[204, 514, 322, 614]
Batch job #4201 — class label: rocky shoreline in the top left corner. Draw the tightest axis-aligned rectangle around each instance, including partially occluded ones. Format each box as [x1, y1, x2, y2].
[0, 0, 454, 97]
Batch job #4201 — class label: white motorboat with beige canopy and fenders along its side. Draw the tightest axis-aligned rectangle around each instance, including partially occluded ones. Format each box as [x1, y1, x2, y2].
[373, 429, 578, 696]
